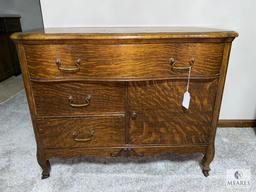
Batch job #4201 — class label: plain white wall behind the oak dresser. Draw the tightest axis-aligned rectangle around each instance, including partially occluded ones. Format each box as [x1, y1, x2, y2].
[41, 0, 256, 119]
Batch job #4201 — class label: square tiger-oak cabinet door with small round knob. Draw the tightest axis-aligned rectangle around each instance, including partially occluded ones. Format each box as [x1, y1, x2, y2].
[128, 79, 218, 145]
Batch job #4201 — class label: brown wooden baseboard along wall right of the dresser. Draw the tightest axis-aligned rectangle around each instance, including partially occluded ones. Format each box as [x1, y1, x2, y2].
[218, 119, 256, 128]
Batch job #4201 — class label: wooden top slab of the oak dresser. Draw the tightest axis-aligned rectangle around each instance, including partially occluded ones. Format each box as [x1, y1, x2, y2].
[12, 27, 238, 40]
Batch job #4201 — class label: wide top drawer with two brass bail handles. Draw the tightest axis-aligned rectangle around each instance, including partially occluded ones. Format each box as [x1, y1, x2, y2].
[25, 43, 224, 79]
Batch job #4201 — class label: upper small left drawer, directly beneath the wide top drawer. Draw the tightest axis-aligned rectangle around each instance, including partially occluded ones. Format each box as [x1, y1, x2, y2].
[31, 82, 125, 116]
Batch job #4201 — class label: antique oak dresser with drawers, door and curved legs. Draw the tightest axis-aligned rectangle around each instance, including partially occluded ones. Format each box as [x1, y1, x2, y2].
[12, 27, 238, 178]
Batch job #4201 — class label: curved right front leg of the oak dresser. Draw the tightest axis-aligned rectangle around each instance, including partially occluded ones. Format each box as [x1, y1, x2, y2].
[202, 144, 215, 177]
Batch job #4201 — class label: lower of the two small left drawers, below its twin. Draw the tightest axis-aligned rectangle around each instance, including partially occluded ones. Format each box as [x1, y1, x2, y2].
[36, 116, 125, 148]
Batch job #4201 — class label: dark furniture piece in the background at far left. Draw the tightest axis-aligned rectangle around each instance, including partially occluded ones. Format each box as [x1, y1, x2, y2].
[0, 15, 21, 81]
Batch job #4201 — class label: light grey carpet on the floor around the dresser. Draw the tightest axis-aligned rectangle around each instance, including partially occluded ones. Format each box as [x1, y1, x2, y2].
[0, 91, 256, 192]
